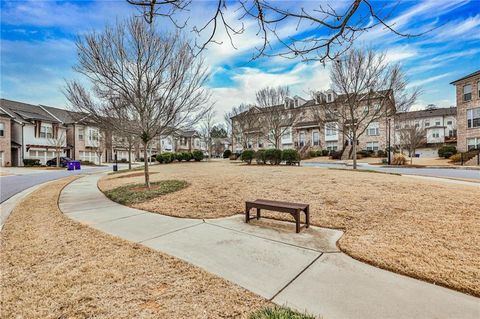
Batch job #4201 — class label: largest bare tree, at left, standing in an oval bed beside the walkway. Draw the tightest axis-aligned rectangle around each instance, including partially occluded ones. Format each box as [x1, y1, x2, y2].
[65, 18, 208, 187]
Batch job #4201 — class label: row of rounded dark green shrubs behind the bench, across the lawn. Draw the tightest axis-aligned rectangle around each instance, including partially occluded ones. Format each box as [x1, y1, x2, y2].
[240, 148, 300, 165]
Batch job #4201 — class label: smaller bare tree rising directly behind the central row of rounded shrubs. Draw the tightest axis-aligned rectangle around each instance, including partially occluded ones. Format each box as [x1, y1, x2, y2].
[256, 86, 299, 148]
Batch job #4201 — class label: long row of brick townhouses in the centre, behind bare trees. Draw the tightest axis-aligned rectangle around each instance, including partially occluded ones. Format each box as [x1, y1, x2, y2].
[231, 90, 394, 158]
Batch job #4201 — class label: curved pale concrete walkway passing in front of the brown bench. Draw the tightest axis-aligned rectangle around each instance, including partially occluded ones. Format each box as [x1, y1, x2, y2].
[59, 175, 480, 318]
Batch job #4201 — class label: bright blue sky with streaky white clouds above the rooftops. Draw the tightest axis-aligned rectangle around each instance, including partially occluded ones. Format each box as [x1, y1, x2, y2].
[0, 0, 480, 118]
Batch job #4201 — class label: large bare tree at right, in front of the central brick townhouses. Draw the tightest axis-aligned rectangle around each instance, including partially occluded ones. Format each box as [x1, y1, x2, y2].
[320, 49, 419, 169]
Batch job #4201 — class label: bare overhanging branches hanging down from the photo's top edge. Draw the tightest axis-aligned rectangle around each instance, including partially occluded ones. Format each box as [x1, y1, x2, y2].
[127, 0, 430, 62]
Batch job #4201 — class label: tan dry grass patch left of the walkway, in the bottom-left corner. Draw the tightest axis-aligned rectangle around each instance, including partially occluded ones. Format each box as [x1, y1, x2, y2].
[0, 178, 269, 318]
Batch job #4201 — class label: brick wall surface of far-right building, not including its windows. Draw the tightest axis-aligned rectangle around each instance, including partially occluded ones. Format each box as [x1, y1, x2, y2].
[452, 71, 480, 152]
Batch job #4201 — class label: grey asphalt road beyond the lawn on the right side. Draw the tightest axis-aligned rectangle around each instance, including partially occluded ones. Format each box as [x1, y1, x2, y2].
[302, 162, 480, 181]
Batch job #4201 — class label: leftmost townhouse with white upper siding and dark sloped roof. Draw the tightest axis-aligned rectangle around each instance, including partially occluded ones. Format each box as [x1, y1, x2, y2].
[0, 99, 69, 166]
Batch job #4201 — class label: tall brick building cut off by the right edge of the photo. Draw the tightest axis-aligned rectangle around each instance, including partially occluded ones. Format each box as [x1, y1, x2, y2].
[450, 70, 480, 152]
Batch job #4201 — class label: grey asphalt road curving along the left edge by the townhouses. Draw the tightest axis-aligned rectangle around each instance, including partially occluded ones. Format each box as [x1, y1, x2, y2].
[0, 167, 118, 203]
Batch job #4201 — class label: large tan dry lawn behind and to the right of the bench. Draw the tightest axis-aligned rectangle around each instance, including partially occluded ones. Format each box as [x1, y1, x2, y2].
[99, 161, 480, 296]
